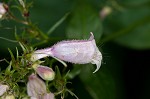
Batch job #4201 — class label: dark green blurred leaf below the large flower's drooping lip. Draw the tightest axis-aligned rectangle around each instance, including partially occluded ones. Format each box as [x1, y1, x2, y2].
[79, 64, 116, 99]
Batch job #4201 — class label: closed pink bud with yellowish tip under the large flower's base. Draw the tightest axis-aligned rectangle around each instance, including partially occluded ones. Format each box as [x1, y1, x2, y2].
[33, 65, 55, 80]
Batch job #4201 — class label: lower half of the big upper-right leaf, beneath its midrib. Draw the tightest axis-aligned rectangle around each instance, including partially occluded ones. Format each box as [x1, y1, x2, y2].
[116, 20, 150, 49]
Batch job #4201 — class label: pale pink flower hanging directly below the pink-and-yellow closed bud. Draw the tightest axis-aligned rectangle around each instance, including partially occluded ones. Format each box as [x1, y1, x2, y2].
[27, 74, 46, 99]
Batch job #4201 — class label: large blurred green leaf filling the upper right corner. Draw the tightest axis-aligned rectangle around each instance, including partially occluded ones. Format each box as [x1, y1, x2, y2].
[104, 0, 150, 49]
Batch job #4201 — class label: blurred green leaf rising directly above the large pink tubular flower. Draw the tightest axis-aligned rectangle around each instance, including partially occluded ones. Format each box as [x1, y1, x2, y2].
[66, 3, 102, 40]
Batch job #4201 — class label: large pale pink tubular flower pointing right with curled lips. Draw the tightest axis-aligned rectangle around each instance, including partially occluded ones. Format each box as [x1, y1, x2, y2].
[31, 32, 102, 73]
